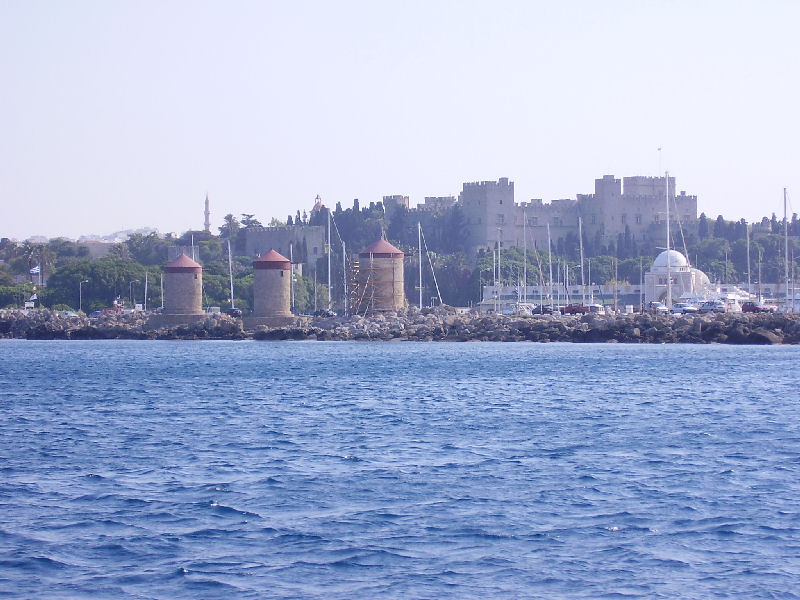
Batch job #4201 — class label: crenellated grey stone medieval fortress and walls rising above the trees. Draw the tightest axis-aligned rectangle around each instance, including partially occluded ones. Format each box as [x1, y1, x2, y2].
[245, 175, 697, 268]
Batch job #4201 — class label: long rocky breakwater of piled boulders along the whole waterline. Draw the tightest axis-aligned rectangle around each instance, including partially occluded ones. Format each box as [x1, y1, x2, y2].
[0, 307, 800, 344]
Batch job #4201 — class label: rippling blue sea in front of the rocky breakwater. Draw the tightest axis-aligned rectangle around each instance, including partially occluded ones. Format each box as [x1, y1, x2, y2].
[0, 340, 800, 600]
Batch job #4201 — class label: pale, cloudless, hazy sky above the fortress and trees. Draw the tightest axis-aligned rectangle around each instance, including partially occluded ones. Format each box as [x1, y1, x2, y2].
[0, 0, 800, 240]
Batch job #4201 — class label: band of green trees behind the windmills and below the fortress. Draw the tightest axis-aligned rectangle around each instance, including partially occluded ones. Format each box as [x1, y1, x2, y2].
[0, 205, 800, 312]
